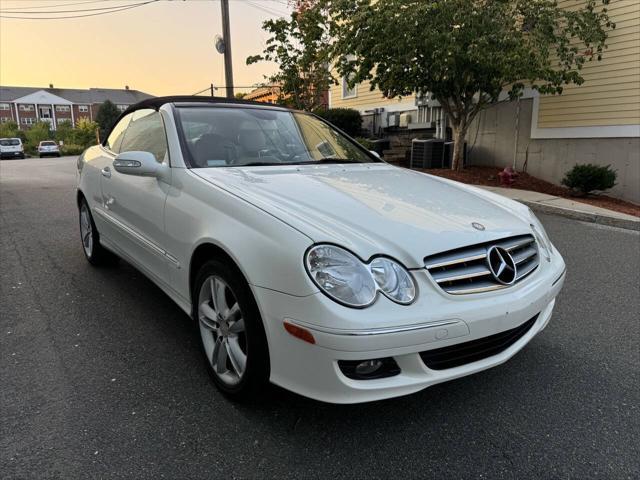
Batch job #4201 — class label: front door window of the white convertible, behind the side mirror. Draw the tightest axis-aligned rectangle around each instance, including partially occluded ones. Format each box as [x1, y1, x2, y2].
[120, 109, 167, 163]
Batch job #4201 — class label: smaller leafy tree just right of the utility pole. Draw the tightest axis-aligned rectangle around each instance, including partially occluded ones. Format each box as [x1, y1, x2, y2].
[247, 0, 334, 111]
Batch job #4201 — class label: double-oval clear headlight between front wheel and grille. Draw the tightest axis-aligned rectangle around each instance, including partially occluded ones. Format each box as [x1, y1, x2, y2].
[305, 245, 416, 307]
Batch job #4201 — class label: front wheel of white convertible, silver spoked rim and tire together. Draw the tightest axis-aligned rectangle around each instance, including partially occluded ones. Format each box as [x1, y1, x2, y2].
[193, 260, 269, 400]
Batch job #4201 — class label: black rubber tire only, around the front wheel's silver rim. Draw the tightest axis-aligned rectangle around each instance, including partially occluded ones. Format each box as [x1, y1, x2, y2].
[191, 259, 270, 401]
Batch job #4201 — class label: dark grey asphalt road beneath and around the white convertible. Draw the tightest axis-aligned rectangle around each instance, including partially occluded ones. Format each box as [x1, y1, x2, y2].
[0, 158, 640, 479]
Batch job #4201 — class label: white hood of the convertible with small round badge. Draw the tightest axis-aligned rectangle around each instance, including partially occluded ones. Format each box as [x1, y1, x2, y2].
[192, 163, 531, 268]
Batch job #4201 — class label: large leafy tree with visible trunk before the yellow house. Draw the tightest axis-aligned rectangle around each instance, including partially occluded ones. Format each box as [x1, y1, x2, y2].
[328, 0, 615, 169]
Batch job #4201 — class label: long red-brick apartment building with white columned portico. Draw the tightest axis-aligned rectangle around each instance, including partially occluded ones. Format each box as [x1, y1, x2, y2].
[0, 85, 152, 130]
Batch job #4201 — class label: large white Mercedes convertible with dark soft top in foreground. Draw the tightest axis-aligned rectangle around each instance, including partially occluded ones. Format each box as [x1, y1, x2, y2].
[77, 97, 565, 403]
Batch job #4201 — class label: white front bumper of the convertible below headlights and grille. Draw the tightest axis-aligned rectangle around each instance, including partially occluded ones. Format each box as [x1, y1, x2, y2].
[253, 246, 565, 403]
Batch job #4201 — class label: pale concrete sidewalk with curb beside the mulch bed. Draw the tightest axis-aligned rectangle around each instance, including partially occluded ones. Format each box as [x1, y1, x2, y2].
[476, 185, 640, 230]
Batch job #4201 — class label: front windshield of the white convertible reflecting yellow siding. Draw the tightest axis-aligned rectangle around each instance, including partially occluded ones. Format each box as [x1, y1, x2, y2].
[178, 107, 376, 168]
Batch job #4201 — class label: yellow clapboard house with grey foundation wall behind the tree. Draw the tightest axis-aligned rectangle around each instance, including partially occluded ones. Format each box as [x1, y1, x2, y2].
[329, 0, 640, 203]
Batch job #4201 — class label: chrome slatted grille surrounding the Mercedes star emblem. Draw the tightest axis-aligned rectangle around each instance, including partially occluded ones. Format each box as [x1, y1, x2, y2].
[424, 235, 539, 295]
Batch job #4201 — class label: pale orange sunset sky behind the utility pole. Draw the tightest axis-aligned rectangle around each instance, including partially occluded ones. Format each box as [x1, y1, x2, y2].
[0, 0, 284, 95]
